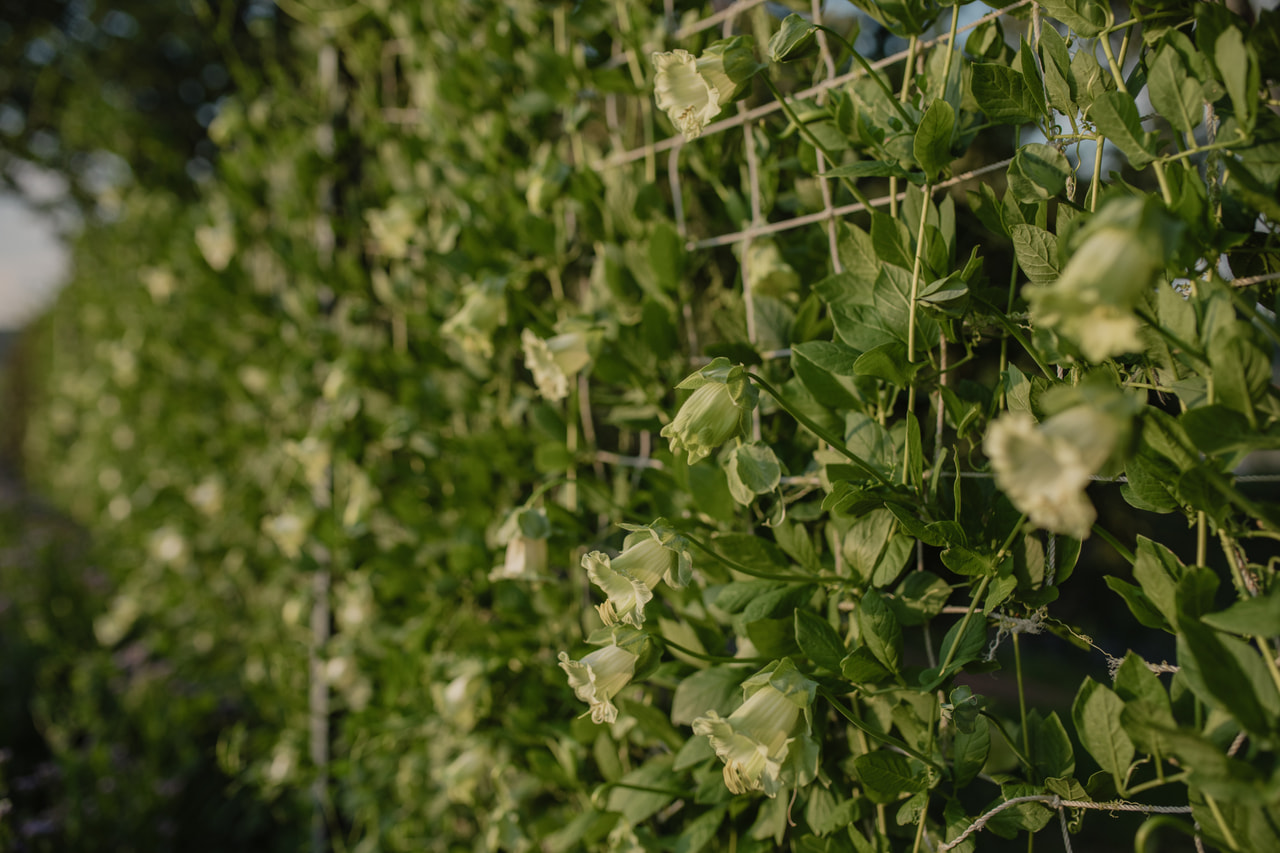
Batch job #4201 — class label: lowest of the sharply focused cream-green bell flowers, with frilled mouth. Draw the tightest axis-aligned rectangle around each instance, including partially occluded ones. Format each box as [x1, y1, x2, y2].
[694, 658, 818, 797]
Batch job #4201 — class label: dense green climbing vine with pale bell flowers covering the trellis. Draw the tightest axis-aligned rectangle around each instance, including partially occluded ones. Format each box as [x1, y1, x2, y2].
[7, 0, 1280, 852]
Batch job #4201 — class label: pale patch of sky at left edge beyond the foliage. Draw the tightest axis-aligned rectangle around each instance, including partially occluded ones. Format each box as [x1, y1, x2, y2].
[0, 195, 67, 329]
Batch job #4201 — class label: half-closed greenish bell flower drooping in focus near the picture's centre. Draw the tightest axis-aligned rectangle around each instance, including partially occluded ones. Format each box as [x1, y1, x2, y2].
[662, 357, 760, 465]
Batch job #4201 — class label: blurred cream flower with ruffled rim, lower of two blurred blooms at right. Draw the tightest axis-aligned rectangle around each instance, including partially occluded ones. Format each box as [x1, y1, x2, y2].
[983, 406, 1120, 539]
